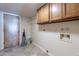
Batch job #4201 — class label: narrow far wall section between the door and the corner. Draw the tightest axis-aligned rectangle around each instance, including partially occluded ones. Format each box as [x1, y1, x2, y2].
[20, 16, 31, 44]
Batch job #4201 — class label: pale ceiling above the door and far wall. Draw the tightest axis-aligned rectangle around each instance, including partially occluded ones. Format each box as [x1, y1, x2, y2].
[0, 3, 44, 17]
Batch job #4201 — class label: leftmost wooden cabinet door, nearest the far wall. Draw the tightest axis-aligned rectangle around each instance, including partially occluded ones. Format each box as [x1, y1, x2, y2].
[37, 4, 50, 23]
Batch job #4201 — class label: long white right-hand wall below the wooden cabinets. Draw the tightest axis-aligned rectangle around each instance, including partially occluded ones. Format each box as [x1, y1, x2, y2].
[32, 18, 79, 56]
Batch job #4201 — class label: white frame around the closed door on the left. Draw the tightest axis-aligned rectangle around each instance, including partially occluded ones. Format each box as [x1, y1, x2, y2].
[3, 12, 20, 49]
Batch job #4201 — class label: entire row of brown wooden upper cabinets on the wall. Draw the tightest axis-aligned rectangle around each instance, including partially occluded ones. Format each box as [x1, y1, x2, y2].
[37, 3, 79, 24]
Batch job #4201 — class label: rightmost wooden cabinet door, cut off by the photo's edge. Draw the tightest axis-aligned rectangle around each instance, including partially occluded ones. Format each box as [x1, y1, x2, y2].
[64, 3, 79, 17]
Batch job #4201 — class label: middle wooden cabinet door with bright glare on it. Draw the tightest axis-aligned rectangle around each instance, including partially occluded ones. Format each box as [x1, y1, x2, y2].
[50, 3, 63, 21]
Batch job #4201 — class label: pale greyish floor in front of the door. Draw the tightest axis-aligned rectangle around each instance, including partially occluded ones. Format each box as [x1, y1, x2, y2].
[0, 44, 48, 56]
